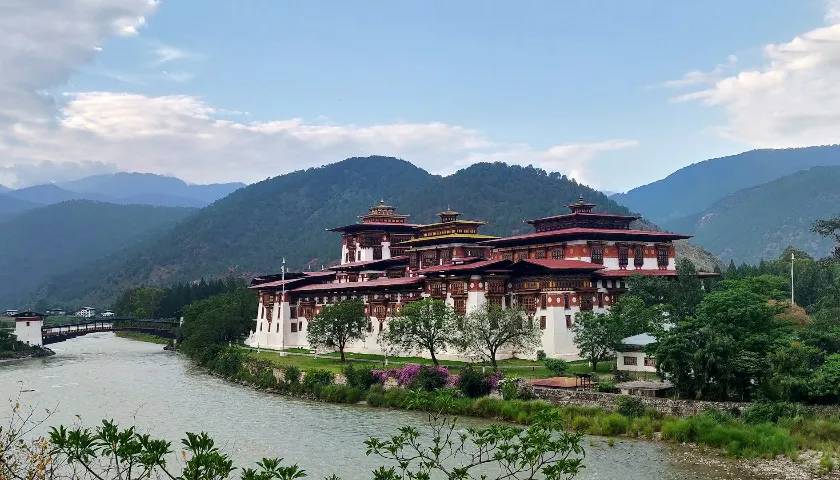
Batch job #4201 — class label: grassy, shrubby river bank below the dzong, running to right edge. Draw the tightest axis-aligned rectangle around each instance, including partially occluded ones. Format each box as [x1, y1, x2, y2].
[190, 349, 840, 478]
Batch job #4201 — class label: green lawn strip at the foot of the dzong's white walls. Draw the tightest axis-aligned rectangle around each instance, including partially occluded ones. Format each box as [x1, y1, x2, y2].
[243, 347, 612, 378]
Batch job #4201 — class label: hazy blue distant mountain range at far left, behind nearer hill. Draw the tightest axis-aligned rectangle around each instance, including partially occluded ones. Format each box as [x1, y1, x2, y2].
[0, 172, 245, 220]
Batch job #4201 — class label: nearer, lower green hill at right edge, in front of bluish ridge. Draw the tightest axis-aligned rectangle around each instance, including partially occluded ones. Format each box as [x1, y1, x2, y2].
[664, 167, 840, 263]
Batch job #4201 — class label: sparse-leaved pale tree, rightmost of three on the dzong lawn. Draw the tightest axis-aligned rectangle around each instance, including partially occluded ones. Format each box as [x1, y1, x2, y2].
[456, 303, 542, 370]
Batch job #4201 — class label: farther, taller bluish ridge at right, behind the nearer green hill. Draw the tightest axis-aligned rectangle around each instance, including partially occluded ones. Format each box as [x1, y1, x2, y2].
[611, 145, 840, 223]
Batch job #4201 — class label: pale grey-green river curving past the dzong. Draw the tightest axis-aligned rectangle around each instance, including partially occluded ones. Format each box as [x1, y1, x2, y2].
[0, 333, 753, 480]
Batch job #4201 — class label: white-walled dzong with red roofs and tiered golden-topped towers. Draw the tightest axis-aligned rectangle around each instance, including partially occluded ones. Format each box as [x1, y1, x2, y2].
[247, 198, 689, 360]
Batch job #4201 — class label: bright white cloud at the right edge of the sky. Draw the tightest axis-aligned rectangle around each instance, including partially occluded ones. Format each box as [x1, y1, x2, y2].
[674, 18, 840, 148]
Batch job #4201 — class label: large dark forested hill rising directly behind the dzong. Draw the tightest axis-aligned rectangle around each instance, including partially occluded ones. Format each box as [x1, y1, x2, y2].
[34, 157, 644, 303]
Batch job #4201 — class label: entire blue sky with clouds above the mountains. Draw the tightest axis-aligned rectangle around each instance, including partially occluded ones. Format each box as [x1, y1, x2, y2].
[0, 0, 840, 191]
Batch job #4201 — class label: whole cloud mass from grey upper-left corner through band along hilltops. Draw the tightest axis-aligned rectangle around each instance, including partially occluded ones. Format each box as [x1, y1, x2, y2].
[0, 0, 636, 186]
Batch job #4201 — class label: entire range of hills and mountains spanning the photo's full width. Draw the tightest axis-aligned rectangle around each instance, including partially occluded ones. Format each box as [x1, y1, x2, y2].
[0, 147, 840, 305]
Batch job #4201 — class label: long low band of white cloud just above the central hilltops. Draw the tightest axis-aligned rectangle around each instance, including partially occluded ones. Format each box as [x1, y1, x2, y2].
[0, 92, 636, 188]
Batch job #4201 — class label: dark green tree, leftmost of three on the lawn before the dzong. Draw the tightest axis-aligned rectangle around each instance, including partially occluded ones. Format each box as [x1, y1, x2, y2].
[306, 299, 368, 362]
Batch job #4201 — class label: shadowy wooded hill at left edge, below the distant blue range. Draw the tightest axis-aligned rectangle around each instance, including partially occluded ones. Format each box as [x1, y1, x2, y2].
[0, 200, 195, 307]
